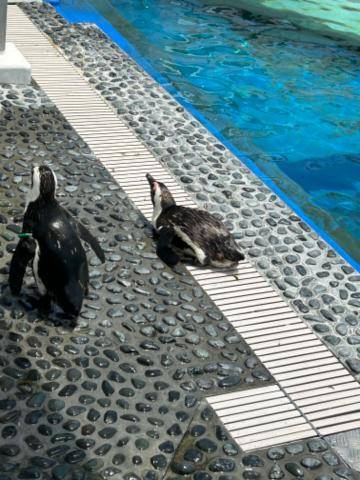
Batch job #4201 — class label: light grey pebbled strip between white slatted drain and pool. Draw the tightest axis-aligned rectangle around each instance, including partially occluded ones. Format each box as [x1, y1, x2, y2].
[22, 4, 360, 378]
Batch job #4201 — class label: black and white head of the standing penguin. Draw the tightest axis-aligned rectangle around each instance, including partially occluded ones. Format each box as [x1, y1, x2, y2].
[26, 165, 57, 205]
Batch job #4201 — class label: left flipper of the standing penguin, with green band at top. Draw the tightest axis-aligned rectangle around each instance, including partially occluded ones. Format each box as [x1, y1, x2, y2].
[9, 238, 36, 295]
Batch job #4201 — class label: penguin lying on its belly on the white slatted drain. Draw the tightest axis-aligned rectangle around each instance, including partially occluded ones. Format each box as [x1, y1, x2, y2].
[146, 173, 244, 267]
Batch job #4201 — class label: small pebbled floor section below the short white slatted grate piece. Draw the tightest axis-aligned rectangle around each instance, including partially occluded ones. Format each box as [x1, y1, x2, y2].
[164, 402, 359, 480]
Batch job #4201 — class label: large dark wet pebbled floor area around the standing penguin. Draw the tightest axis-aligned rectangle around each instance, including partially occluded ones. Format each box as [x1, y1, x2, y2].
[0, 81, 273, 480]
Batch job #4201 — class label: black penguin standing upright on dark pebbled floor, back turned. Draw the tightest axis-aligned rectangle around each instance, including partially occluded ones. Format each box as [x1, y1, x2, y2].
[9, 165, 105, 318]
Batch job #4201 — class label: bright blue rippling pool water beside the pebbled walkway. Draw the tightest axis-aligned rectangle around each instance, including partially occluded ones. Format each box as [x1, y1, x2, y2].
[54, 0, 360, 269]
